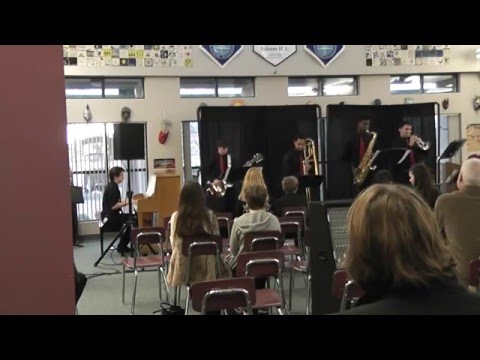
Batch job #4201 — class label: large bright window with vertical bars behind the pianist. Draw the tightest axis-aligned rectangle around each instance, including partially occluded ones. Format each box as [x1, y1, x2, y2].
[67, 123, 148, 221]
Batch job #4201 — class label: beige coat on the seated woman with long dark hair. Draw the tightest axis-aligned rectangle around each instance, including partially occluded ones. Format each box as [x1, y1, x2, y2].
[167, 212, 232, 287]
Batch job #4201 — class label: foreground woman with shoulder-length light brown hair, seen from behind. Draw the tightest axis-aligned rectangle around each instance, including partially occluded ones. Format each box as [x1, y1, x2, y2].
[342, 184, 480, 315]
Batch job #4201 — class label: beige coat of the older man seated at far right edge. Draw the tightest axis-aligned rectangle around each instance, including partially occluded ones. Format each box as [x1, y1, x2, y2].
[435, 186, 480, 283]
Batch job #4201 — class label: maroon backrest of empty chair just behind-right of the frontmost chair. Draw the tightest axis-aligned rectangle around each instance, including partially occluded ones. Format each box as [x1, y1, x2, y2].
[237, 250, 285, 278]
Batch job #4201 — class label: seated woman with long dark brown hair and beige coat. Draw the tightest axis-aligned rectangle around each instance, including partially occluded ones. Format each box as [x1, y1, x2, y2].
[167, 181, 231, 287]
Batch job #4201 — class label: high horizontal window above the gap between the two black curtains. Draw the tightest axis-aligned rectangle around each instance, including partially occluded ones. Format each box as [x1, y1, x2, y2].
[288, 76, 358, 96]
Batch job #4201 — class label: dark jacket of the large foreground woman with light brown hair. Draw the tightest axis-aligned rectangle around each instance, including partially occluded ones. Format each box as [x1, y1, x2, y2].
[340, 278, 480, 315]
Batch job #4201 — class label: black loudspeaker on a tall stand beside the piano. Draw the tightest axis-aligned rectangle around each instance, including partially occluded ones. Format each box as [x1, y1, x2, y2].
[113, 123, 145, 160]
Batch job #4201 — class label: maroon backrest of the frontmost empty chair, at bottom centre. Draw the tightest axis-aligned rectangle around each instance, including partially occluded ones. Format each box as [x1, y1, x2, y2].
[191, 277, 256, 313]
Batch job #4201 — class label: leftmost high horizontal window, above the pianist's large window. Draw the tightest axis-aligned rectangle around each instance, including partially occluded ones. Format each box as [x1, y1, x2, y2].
[65, 77, 145, 99]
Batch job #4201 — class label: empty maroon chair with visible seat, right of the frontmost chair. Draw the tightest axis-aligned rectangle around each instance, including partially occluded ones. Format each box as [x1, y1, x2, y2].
[237, 250, 288, 315]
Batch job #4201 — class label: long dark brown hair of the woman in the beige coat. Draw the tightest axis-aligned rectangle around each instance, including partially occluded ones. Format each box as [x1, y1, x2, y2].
[175, 181, 211, 236]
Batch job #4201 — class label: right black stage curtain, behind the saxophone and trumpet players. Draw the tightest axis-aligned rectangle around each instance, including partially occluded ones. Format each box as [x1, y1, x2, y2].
[323, 103, 438, 200]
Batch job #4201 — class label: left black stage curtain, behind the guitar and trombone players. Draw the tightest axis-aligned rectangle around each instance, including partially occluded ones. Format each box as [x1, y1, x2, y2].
[197, 105, 321, 198]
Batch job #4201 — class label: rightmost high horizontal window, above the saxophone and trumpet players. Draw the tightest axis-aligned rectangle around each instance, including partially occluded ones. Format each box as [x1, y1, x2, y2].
[390, 74, 458, 95]
